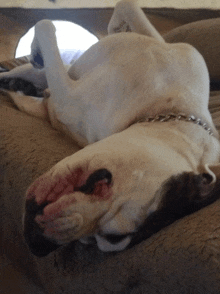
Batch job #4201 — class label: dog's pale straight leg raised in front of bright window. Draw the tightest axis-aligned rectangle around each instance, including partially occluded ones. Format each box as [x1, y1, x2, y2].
[29, 20, 93, 146]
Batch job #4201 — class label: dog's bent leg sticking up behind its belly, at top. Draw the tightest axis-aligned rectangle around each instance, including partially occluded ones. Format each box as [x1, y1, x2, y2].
[108, 0, 164, 42]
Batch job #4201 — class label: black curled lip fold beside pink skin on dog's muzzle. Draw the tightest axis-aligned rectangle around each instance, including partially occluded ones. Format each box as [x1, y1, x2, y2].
[75, 168, 112, 194]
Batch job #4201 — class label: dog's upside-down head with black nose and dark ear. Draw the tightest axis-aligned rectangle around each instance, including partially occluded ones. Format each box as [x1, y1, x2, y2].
[24, 128, 218, 256]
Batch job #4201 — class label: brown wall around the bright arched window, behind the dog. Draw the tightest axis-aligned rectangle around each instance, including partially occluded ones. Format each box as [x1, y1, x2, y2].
[0, 0, 220, 61]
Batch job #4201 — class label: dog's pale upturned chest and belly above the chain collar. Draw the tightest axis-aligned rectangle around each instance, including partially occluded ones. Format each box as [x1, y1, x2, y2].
[52, 33, 211, 145]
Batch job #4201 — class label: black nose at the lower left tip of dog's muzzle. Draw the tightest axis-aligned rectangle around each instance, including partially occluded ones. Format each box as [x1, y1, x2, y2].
[24, 199, 60, 257]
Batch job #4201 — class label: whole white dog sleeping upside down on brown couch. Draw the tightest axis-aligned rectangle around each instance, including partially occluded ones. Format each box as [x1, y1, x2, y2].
[0, 1, 220, 255]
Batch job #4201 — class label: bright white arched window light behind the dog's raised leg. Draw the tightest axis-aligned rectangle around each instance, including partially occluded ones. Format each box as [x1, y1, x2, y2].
[15, 20, 98, 64]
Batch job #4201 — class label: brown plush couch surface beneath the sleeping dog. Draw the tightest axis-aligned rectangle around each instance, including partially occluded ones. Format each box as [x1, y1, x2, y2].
[0, 16, 220, 294]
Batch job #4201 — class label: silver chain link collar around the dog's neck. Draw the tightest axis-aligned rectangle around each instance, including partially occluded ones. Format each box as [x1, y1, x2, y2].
[137, 113, 214, 136]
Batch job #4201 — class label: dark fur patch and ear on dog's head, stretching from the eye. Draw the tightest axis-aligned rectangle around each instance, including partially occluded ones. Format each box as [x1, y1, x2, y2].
[129, 169, 220, 248]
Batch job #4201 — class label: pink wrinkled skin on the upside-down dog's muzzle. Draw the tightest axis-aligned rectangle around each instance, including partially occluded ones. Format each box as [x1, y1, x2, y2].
[26, 168, 112, 237]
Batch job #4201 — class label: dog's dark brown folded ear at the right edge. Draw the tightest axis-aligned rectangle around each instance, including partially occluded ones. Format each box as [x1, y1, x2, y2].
[158, 166, 220, 219]
